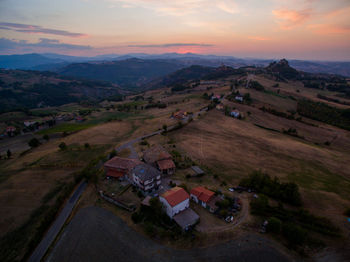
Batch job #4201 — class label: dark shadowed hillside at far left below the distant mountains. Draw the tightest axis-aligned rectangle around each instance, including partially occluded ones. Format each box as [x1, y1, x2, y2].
[0, 70, 120, 112]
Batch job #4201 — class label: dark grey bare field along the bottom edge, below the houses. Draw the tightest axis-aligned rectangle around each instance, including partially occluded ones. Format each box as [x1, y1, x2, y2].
[48, 207, 298, 262]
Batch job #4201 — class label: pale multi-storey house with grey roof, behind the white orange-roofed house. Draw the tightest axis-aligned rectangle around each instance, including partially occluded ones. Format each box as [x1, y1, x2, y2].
[131, 163, 161, 194]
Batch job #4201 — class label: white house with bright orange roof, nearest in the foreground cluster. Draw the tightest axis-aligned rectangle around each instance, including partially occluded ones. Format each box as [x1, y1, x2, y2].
[159, 187, 190, 218]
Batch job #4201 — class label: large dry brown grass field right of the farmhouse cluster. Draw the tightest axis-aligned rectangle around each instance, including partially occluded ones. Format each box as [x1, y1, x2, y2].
[170, 109, 350, 231]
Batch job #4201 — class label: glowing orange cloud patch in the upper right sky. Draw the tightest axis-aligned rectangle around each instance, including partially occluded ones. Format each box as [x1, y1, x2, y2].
[272, 9, 311, 29]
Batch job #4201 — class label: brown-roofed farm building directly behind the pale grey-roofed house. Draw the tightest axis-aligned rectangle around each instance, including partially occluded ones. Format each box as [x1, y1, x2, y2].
[143, 145, 175, 175]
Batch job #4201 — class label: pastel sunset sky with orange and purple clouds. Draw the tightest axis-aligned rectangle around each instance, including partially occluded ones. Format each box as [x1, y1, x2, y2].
[0, 0, 350, 61]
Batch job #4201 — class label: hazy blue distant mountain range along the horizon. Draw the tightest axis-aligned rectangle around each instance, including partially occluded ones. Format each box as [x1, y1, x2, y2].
[0, 53, 350, 78]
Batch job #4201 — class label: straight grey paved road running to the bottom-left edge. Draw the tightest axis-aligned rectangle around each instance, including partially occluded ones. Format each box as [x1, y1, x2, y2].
[28, 181, 86, 262]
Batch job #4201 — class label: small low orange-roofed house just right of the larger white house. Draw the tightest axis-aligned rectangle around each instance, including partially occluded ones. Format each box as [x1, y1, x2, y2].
[190, 187, 218, 213]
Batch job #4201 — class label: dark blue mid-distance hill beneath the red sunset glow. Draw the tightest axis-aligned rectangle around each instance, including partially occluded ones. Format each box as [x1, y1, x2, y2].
[57, 58, 183, 88]
